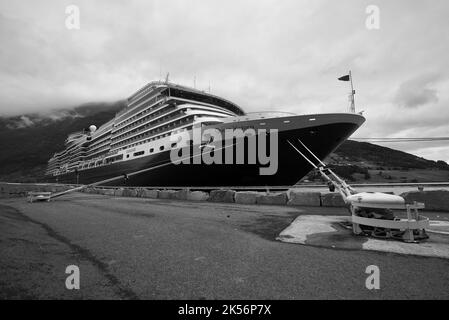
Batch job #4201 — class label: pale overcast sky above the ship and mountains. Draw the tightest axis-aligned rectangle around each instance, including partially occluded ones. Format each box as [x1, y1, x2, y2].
[0, 0, 449, 161]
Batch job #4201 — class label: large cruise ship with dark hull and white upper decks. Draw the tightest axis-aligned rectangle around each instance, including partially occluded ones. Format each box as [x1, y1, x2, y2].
[46, 81, 365, 187]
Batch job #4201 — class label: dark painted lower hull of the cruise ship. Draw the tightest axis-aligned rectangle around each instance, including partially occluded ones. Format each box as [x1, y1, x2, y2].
[47, 117, 364, 187]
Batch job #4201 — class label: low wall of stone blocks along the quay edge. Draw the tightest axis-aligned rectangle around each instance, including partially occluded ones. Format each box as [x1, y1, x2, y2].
[0, 182, 449, 212]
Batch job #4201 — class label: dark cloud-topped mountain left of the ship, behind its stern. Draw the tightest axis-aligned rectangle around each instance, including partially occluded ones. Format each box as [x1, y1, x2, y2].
[0, 101, 125, 182]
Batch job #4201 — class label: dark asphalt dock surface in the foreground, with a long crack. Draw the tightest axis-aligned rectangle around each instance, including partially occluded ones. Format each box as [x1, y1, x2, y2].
[0, 193, 449, 299]
